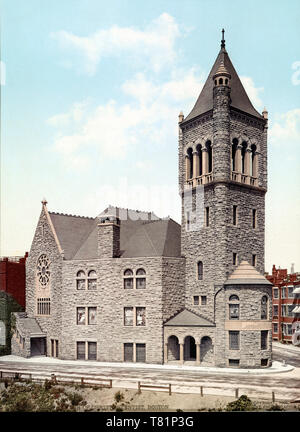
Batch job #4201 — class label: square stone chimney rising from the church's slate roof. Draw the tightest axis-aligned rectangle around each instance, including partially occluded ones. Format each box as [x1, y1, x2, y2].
[98, 214, 120, 258]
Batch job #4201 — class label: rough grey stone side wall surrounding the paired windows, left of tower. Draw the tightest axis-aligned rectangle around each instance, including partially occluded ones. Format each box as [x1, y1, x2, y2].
[60, 257, 170, 363]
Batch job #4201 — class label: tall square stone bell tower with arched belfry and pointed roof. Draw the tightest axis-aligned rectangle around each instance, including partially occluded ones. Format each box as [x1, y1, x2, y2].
[179, 30, 268, 368]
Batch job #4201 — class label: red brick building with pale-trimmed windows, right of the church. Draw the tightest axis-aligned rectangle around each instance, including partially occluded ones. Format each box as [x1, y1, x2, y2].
[266, 265, 300, 345]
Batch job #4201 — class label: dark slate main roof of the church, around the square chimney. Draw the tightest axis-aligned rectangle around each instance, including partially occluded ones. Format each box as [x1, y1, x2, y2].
[49, 207, 181, 260]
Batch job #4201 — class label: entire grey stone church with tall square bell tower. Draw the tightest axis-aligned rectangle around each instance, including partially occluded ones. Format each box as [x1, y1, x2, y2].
[12, 35, 272, 368]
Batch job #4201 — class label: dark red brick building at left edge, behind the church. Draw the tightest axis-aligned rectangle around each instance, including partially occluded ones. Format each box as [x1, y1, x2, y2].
[0, 253, 28, 355]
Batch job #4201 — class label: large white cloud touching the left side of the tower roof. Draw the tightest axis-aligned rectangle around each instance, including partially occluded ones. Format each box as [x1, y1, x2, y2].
[48, 69, 203, 166]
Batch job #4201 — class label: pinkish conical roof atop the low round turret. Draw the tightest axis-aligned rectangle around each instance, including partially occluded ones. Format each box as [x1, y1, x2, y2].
[224, 261, 272, 285]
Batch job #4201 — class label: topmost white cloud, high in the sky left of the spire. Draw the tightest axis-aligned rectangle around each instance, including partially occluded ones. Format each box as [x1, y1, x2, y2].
[51, 13, 180, 75]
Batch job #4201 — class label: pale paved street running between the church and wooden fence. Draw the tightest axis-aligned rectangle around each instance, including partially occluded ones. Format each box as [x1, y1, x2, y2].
[0, 347, 300, 400]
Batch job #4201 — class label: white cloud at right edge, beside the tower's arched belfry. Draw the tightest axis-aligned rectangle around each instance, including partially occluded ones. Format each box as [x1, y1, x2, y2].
[269, 108, 300, 146]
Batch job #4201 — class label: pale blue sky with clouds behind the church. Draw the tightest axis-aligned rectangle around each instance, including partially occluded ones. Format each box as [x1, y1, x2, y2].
[1, 0, 300, 271]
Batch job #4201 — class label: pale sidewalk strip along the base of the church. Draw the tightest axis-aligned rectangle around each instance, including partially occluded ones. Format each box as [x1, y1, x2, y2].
[0, 355, 295, 375]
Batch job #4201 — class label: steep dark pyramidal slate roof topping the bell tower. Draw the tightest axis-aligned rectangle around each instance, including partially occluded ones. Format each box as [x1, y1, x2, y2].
[181, 48, 263, 124]
